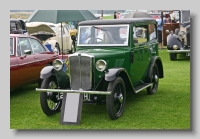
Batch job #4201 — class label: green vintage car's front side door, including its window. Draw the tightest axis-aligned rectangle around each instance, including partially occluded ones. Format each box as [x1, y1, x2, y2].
[130, 25, 150, 85]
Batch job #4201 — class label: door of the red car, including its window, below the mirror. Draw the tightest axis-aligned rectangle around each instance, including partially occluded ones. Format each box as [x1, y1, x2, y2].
[17, 37, 39, 84]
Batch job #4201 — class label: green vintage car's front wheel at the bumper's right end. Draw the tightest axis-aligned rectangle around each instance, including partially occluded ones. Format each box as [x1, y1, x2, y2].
[106, 77, 126, 120]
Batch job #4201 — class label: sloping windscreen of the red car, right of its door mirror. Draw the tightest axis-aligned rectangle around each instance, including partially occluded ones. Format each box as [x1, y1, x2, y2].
[30, 38, 46, 53]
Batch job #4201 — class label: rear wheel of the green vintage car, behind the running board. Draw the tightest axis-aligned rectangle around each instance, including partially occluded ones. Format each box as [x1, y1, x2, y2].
[147, 63, 159, 95]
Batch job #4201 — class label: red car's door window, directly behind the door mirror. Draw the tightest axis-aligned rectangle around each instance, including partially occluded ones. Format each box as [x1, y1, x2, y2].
[17, 37, 33, 55]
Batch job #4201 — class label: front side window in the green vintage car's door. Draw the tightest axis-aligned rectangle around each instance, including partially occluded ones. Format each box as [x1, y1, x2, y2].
[133, 26, 147, 43]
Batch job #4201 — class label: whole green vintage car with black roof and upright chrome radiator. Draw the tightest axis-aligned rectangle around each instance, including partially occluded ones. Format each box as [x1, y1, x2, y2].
[36, 18, 164, 120]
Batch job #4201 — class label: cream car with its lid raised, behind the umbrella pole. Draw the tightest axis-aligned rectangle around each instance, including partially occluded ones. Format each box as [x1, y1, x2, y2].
[26, 22, 75, 54]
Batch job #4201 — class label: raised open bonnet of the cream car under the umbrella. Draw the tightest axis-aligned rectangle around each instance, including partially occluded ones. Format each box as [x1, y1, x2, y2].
[26, 22, 55, 34]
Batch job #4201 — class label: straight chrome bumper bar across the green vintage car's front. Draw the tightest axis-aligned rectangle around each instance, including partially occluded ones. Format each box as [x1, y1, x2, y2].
[36, 88, 111, 95]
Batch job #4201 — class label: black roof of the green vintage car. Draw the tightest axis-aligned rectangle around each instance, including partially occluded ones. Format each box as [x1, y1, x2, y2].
[79, 18, 156, 25]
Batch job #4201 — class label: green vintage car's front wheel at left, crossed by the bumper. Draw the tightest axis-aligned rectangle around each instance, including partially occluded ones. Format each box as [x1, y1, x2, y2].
[40, 76, 62, 116]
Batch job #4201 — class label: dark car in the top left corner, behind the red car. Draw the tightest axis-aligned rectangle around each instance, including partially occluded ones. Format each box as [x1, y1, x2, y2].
[10, 18, 23, 34]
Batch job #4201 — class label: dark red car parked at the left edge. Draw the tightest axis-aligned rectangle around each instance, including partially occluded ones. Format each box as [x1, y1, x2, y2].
[10, 34, 59, 91]
